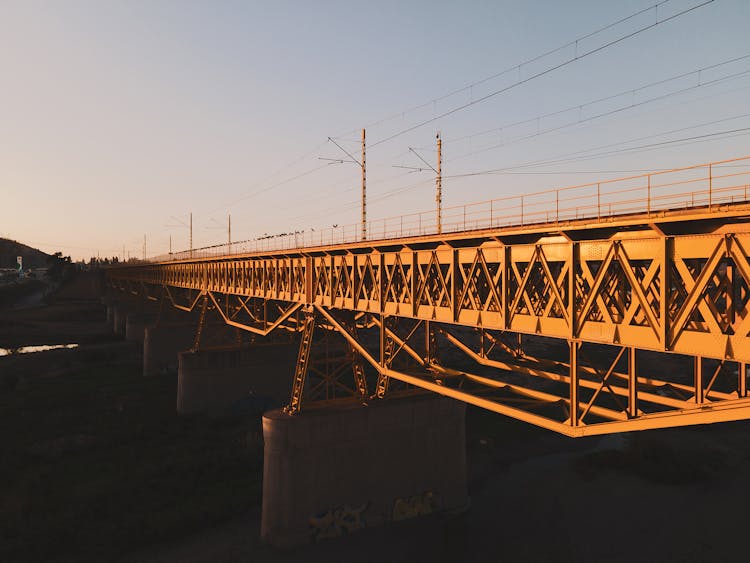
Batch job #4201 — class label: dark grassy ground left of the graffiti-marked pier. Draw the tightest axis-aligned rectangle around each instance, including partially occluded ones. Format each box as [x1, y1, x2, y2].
[0, 363, 262, 563]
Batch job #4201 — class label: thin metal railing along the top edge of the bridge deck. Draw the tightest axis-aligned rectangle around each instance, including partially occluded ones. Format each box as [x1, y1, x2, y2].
[150, 156, 750, 262]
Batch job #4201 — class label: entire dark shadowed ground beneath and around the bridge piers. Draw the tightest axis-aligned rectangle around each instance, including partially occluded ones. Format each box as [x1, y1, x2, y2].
[0, 272, 750, 563]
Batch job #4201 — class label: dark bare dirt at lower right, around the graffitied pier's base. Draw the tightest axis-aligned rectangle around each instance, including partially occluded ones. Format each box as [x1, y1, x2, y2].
[114, 411, 750, 563]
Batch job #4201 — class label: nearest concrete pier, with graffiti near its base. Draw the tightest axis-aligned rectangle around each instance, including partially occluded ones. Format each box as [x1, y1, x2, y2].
[261, 396, 468, 547]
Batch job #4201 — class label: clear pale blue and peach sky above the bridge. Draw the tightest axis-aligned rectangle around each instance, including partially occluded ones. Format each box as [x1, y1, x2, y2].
[0, 0, 750, 259]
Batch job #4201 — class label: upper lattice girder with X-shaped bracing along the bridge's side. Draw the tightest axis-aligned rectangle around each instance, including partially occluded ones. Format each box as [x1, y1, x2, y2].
[110, 233, 750, 362]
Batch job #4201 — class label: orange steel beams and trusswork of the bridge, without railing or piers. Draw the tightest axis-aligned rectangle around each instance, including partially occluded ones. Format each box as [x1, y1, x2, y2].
[107, 197, 750, 436]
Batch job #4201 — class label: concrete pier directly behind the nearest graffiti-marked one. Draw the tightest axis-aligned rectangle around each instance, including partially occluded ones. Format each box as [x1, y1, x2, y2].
[177, 344, 297, 414]
